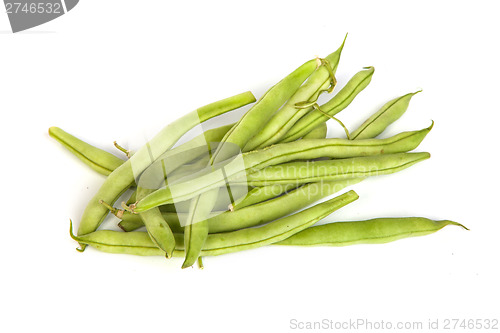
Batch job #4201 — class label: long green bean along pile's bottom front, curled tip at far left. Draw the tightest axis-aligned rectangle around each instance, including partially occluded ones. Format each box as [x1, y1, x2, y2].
[70, 191, 358, 256]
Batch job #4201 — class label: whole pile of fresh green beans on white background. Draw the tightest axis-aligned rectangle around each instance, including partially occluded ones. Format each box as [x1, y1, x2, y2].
[49, 40, 466, 268]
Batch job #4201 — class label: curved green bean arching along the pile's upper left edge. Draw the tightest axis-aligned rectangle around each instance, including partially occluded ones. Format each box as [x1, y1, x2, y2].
[78, 92, 255, 250]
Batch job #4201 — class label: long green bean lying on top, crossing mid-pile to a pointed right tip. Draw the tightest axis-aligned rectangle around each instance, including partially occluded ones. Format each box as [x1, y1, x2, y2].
[134, 125, 432, 208]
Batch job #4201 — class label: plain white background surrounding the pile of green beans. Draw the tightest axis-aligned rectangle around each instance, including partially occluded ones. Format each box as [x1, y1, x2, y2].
[0, 0, 500, 332]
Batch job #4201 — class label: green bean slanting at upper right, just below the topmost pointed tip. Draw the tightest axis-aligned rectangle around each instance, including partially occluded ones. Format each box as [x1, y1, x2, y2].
[280, 67, 375, 142]
